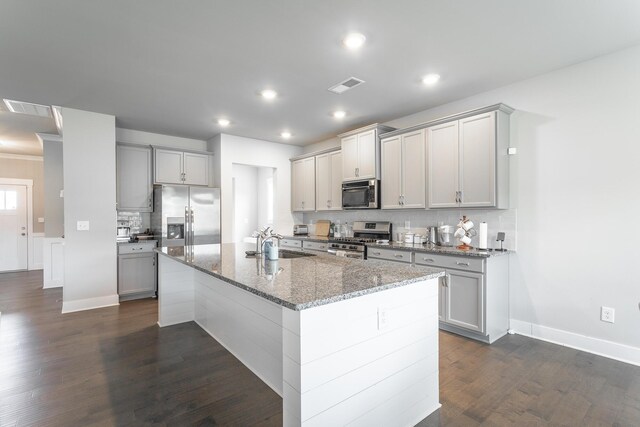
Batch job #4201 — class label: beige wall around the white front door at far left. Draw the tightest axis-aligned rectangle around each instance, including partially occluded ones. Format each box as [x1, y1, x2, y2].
[0, 157, 44, 233]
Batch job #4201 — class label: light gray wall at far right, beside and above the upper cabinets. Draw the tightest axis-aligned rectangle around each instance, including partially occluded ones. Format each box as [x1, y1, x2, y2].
[305, 46, 640, 360]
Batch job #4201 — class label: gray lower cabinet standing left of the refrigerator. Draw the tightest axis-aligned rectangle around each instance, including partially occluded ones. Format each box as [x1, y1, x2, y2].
[118, 241, 157, 301]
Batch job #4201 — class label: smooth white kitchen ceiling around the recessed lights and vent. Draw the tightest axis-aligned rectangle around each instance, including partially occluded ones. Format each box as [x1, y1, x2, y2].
[0, 0, 640, 149]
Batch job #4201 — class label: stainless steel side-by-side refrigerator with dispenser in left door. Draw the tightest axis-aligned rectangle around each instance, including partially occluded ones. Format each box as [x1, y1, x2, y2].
[151, 185, 220, 247]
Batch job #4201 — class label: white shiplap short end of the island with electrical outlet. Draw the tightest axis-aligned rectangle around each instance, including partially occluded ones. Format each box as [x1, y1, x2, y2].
[283, 279, 440, 426]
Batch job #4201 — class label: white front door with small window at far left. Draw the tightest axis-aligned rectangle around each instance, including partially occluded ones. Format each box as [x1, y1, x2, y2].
[0, 185, 27, 272]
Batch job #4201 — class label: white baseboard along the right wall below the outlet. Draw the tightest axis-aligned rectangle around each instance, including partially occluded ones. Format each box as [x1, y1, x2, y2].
[509, 319, 640, 366]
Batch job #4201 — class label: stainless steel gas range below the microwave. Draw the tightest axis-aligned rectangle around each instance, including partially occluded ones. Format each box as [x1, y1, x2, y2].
[327, 221, 391, 259]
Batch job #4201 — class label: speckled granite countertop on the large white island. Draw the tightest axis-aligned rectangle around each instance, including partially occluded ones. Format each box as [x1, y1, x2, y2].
[156, 243, 444, 311]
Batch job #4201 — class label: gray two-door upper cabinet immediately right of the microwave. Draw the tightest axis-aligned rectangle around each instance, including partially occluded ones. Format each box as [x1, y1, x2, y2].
[381, 130, 426, 209]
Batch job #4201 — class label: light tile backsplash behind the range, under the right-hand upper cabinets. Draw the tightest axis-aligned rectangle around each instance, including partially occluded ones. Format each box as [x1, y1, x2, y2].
[302, 209, 517, 250]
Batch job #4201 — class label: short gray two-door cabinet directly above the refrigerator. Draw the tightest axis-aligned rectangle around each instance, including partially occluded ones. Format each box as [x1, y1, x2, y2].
[154, 148, 209, 186]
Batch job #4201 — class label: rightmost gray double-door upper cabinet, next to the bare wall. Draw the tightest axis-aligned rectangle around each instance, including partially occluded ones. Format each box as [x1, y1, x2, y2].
[427, 104, 513, 209]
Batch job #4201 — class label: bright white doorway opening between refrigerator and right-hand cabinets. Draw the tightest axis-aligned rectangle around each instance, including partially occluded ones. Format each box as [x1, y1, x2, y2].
[232, 163, 275, 243]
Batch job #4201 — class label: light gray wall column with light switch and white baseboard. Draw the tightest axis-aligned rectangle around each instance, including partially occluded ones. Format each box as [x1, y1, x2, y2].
[62, 108, 118, 312]
